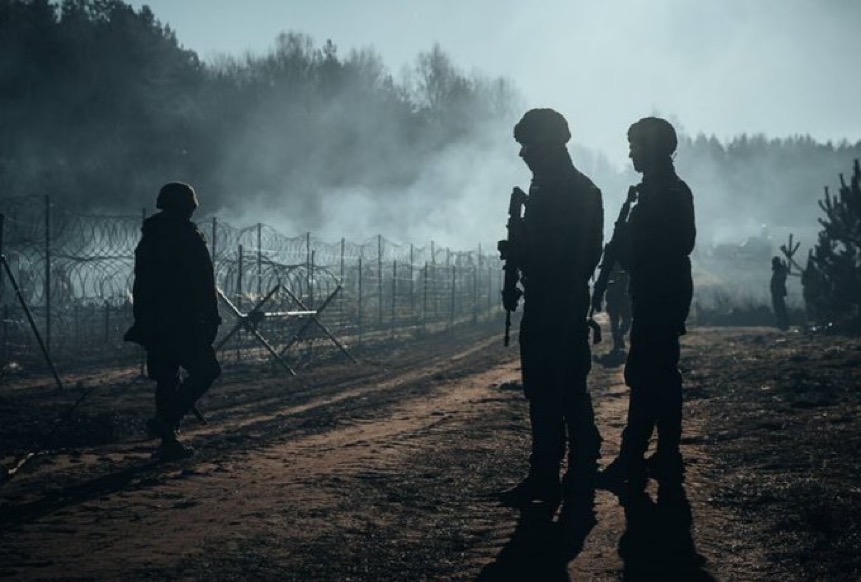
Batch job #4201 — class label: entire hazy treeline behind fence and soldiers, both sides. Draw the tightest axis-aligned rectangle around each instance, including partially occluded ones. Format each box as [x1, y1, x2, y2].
[0, 0, 861, 248]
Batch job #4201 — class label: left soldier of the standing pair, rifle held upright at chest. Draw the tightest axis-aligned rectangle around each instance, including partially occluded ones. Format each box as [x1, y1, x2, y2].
[514, 109, 604, 502]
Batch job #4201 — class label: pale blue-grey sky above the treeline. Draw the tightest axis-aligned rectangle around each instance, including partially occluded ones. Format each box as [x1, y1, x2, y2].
[130, 0, 861, 165]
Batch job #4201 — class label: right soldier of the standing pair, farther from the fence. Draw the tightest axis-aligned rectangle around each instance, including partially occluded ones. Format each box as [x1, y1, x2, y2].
[605, 117, 696, 486]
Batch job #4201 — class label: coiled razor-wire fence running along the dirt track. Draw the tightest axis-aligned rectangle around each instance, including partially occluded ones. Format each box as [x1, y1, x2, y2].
[0, 197, 501, 378]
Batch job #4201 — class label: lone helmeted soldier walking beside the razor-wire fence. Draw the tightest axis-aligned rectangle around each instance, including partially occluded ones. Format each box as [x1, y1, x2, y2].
[124, 182, 221, 460]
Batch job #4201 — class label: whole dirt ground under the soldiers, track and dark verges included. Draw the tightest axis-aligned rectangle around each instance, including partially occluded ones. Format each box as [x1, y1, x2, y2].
[0, 322, 861, 580]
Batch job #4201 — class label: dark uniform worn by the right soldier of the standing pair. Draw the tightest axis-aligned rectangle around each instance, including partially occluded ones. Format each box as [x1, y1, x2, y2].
[620, 165, 696, 476]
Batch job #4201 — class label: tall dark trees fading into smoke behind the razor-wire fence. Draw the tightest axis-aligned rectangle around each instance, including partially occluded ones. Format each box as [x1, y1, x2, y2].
[0, 0, 517, 215]
